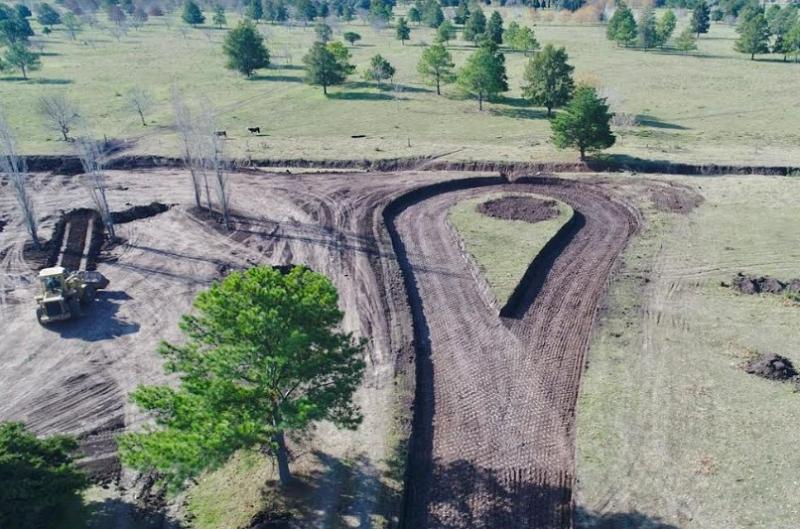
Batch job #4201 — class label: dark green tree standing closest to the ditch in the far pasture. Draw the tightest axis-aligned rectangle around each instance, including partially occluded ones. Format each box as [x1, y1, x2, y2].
[551, 85, 616, 160]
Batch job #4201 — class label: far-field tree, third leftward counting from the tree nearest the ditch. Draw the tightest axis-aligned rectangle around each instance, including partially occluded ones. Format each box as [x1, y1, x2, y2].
[458, 40, 508, 110]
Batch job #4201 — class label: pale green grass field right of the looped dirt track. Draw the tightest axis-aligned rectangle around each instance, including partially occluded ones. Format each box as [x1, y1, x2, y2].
[577, 177, 800, 529]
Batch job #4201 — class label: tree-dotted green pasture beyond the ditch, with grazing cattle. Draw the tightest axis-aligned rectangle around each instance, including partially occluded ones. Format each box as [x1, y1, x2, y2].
[0, 7, 800, 164]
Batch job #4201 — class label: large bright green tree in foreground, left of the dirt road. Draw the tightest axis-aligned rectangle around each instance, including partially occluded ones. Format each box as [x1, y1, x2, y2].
[119, 266, 365, 486]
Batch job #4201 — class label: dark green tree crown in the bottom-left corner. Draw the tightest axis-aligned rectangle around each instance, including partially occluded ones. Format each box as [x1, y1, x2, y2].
[0, 422, 87, 529]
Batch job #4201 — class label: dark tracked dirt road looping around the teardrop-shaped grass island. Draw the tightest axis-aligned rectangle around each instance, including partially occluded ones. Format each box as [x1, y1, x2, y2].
[388, 179, 637, 529]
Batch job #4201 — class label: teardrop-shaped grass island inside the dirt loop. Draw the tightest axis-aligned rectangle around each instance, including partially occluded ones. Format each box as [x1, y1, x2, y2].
[447, 193, 573, 307]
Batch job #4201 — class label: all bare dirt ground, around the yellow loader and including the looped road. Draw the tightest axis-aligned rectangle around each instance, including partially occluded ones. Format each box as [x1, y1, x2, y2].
[0, 170, 637, 528]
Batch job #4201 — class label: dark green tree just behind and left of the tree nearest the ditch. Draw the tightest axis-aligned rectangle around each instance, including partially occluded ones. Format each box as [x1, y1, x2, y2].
[522, 44, 575, 116]
